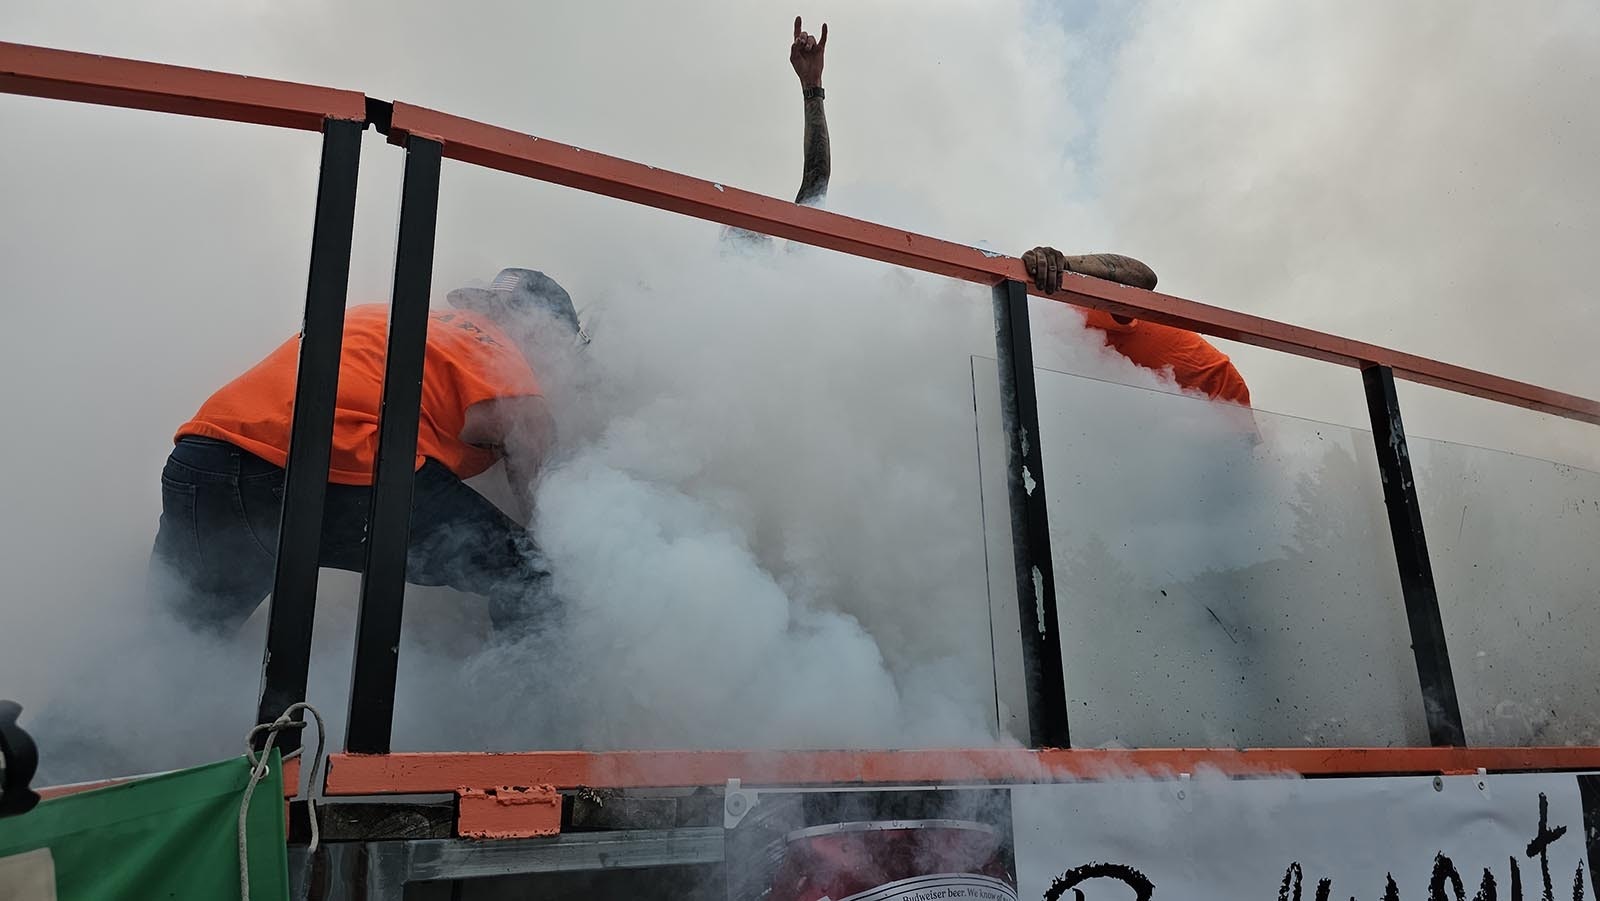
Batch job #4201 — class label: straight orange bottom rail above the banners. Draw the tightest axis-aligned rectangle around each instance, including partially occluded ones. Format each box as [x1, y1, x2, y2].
[325, 747, 1600, 795]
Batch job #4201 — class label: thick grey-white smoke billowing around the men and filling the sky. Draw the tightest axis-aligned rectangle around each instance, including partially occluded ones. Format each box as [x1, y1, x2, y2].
[0, 0, 1600, 778]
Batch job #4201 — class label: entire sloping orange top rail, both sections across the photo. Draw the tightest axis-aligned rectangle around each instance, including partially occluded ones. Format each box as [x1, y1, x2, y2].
[0, 42, 1600, 424]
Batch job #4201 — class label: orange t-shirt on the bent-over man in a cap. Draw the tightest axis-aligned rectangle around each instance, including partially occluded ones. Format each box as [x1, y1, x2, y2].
[174, 304, 539, 485]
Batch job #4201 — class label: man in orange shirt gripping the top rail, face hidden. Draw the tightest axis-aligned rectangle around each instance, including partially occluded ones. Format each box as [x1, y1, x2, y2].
[1022, 246, 1250, 406]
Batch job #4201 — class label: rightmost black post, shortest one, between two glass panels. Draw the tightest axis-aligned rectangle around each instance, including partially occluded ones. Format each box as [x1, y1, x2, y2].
[1362, 365, 1467, 747]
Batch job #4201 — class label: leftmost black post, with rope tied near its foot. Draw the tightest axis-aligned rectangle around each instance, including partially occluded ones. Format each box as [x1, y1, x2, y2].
[256, 118, 366, 752]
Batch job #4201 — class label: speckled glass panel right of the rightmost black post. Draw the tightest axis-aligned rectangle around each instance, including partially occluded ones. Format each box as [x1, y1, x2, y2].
[1408, 438, 1600, 746]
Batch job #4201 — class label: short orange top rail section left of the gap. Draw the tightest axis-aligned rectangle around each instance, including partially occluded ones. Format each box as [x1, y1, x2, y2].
[0, 42, 366, 131]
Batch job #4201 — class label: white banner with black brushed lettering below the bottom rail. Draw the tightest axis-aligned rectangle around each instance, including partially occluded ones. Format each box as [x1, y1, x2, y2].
[1011, 773, 1592, 901]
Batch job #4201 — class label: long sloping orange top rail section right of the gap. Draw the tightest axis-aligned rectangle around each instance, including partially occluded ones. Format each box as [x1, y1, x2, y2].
[389, 102, 1600, 424]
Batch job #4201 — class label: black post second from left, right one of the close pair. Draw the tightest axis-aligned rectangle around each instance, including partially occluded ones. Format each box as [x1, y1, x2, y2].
[346, 136, 443, 754]
